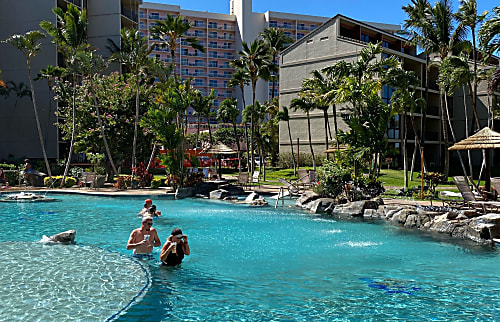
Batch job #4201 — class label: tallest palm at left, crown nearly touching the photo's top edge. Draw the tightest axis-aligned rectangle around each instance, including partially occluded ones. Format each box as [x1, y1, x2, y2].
[40, 3, 88, 187]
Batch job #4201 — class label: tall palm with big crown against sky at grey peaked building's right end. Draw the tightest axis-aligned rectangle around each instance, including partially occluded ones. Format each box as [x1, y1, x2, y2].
[403, 0, 470, 175]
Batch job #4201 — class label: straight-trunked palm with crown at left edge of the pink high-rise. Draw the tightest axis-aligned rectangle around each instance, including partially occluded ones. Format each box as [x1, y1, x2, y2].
[108, 28, 152, 178]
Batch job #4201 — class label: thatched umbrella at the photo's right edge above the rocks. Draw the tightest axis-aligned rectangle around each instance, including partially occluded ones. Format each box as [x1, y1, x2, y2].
[448, 127, 500, 191]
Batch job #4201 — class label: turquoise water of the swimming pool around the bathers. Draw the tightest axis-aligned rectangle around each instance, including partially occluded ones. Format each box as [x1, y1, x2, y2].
[0, 195, 500, 321]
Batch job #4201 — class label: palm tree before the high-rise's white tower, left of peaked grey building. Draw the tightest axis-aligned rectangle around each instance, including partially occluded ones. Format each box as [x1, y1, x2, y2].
[233, 39, 271, 173]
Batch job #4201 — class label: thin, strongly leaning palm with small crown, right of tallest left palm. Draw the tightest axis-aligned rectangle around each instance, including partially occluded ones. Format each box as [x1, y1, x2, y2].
[72, 50, 118, 175]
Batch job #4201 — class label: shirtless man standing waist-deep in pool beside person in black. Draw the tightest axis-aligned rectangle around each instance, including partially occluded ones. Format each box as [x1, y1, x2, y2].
[127, 216, 161, 259]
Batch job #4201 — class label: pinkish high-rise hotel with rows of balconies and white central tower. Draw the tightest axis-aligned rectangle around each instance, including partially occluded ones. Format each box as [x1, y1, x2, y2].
[139, 0, 328, 128]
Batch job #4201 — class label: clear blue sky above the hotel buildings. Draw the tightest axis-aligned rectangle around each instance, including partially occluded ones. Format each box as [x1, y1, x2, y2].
[153, 0, 500, 25]
